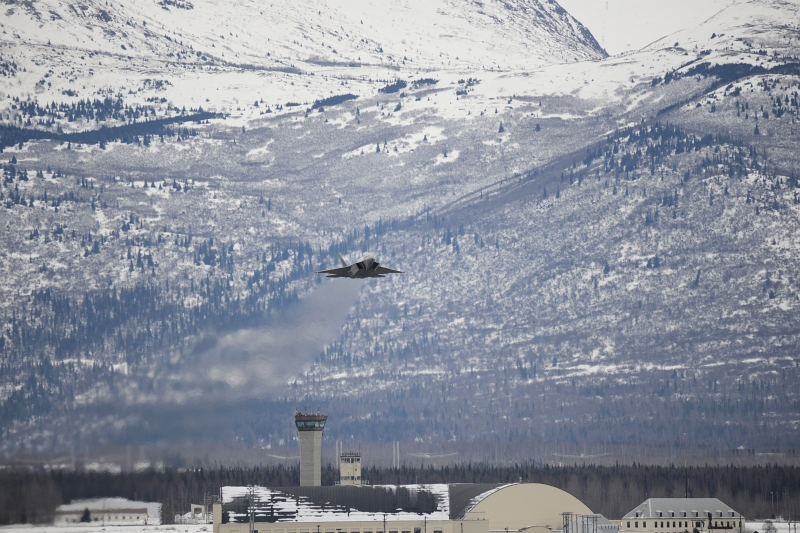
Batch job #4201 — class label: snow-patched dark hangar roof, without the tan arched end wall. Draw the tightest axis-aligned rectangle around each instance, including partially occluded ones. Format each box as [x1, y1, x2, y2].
[222, 483, 503, 522]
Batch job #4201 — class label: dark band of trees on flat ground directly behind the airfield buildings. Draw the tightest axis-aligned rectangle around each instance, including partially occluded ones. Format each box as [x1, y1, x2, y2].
[0, 463, 800, 524]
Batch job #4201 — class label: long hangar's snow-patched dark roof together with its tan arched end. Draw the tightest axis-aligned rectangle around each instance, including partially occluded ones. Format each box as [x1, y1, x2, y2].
[222, 483, 592, 533]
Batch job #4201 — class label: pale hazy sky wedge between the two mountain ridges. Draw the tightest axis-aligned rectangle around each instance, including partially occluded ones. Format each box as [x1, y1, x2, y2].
[558, 0, 741, 55]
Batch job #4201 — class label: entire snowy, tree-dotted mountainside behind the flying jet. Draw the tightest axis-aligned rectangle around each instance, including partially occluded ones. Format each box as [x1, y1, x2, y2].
[0, 0, 800, 460]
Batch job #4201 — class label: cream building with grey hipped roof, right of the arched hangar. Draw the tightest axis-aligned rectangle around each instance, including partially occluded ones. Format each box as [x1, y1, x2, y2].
[619, 498, 745, 533]
